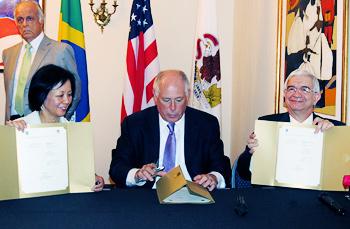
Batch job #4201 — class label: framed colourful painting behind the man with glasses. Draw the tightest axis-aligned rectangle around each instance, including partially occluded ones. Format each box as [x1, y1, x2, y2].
[275, 0, 349, 122]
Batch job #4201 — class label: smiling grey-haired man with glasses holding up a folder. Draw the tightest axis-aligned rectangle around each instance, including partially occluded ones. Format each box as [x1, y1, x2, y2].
[236, 69, 345, 181]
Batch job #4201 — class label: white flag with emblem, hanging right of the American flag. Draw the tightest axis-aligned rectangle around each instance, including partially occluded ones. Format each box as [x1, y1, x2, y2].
[192, 0, 221, 123]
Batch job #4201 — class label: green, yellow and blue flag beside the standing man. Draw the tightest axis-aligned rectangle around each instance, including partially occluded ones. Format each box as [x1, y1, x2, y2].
[58, 0, 90, 122]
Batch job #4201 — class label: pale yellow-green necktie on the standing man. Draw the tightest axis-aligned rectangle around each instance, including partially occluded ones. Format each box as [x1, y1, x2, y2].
[15, 43, 32, 115]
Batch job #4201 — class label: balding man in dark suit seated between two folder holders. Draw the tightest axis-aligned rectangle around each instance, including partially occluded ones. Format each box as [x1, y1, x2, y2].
[109, 70, 227, 191]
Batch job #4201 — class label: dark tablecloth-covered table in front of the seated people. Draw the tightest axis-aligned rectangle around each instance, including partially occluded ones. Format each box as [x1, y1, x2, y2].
[0, 187, 350, 229]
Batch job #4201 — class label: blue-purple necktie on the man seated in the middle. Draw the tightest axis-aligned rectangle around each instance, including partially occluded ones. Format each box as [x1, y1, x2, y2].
[163, 122, 176, 172]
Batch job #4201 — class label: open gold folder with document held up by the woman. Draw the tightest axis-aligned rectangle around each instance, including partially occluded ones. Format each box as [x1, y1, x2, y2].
[0, 123, 95, 200]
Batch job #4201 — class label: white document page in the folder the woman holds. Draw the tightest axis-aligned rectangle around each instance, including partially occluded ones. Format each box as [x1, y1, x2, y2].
[16, 127, 68, 193]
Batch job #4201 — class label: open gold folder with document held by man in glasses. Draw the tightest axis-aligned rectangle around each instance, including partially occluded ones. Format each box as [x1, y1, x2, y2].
[251, 120, 350, 191]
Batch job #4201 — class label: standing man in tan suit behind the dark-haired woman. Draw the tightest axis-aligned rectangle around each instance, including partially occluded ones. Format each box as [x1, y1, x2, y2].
[3, 0, 81, 120]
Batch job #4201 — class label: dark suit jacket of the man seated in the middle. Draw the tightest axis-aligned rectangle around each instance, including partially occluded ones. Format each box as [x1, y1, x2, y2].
[109, 106, 230, 187]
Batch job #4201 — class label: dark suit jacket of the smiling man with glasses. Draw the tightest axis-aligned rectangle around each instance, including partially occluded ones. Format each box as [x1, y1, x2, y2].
[237, 112, 345, 181]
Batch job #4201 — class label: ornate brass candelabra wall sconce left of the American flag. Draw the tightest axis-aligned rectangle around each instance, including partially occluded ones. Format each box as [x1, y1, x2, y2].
[89, 0, 118, 33]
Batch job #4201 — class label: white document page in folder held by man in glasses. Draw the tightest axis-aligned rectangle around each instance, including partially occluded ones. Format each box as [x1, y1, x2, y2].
[276, 126, 323, 186]
